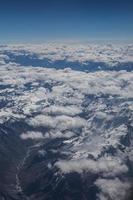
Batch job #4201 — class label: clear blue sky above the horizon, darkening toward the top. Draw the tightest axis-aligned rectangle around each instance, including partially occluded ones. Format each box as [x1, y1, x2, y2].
[0, 0, 133, 42]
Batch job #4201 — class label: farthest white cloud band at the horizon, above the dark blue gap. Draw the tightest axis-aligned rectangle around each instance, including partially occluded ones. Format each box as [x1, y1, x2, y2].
[1, 43, 133, 68]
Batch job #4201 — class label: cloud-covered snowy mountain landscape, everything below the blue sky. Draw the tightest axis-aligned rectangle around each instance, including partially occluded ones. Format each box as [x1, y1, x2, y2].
[0, 43, 133, 200]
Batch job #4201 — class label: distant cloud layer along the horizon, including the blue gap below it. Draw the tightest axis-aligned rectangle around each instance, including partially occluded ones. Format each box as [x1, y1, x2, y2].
[0, 42, 133, 71]
